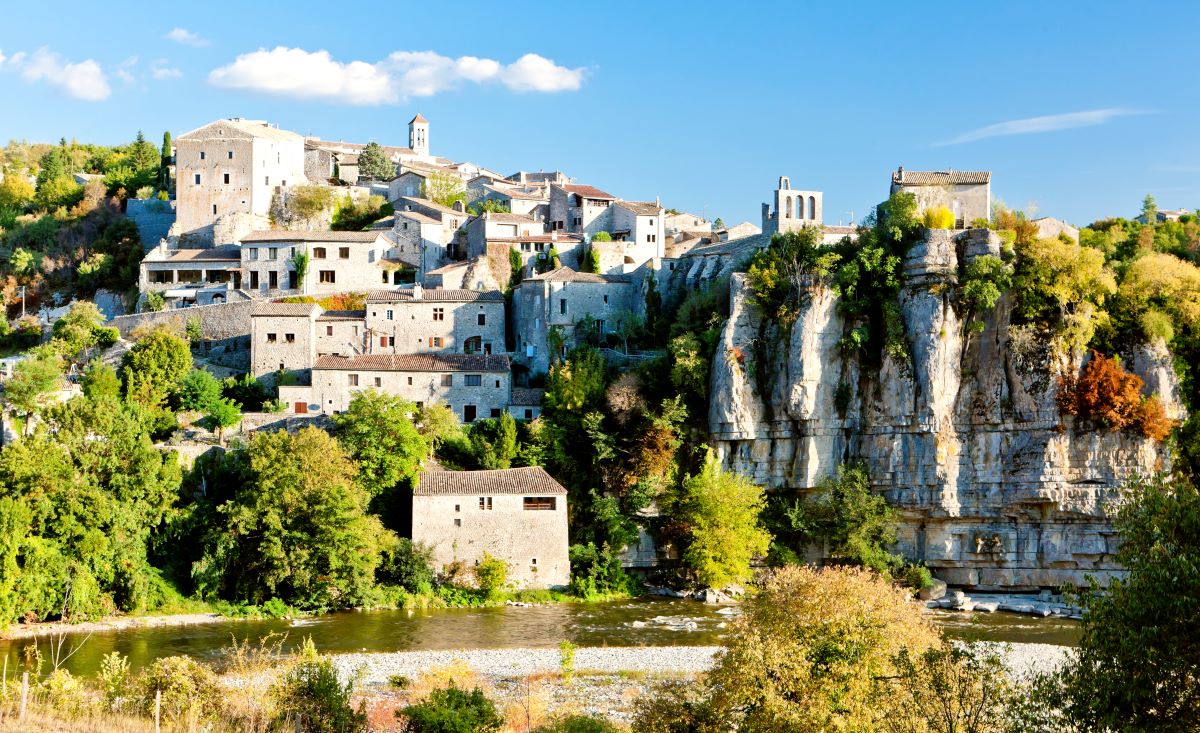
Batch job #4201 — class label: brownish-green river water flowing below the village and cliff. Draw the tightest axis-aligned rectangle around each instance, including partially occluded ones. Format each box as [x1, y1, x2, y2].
[0, 599, 1079, 675]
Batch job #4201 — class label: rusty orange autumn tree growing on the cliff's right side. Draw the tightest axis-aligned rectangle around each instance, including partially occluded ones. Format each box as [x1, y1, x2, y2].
[1058, 350, 1175, 440]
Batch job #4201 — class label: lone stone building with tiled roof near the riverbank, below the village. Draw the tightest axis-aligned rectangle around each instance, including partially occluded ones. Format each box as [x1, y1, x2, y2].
[412, 467, 571, 588]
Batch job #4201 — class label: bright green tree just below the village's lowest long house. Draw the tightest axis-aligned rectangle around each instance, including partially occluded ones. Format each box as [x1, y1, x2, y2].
[334, 390, 431, 497]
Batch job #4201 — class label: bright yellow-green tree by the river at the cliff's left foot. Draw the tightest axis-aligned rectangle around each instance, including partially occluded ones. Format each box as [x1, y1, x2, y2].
[678, 449, 770, 588]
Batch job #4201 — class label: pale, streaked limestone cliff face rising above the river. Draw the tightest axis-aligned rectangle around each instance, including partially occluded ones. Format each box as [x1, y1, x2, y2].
[709, 230, 1183, 590]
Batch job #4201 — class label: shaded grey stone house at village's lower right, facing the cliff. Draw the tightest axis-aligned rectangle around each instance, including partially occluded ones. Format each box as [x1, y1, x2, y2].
[512, 268, 637, 374]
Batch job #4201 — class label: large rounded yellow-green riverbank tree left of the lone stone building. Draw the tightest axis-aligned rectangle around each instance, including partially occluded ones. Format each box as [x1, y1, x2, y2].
[192, 427, 395, 608]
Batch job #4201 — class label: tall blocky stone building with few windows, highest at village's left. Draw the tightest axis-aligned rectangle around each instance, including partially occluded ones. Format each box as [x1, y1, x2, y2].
[172, 118, 307, 245]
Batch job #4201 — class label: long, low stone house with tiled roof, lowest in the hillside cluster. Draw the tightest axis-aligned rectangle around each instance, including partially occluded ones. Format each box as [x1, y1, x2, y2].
[278, 353, 512, 422]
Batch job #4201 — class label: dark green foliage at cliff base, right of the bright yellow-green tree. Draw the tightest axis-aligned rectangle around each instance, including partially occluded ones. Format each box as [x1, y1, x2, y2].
[772, 463, 901, 577]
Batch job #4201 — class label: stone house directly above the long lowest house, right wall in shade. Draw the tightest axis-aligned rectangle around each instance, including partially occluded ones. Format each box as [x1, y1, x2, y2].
[365, 284, 506, 354]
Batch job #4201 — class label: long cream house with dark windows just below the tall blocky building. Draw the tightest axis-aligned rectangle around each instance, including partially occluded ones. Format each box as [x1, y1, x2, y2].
[241, 229, 404, 295]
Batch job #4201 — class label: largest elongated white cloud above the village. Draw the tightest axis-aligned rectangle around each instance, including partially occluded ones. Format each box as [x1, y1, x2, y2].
[209, 46, 583, 104]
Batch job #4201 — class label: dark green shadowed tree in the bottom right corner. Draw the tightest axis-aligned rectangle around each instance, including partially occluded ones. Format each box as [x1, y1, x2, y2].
[1061, 475, 1200, 732]
